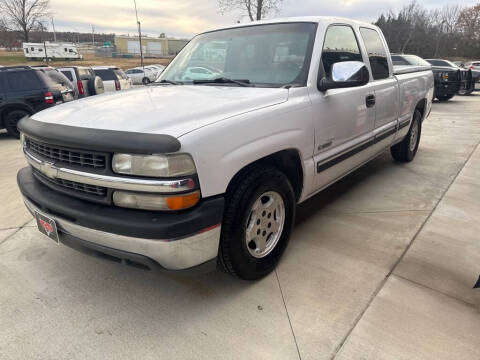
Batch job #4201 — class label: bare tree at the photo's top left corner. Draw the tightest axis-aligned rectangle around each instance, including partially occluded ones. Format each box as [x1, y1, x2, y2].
[0, 0, 49, 42]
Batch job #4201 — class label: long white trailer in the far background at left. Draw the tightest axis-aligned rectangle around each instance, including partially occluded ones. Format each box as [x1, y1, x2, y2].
[23, 42, 83, 60]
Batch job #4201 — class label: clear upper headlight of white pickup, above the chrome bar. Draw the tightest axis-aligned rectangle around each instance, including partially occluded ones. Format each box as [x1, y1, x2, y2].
[112, 154, 196, 177]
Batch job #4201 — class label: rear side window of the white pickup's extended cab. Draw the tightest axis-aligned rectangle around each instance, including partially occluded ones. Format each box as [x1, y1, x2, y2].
[360, 28, 390, 80]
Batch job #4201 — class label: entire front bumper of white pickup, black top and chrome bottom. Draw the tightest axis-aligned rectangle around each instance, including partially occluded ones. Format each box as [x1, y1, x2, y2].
[17, 168, 224, 270]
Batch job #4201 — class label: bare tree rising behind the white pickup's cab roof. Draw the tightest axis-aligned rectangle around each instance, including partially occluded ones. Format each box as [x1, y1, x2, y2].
[218, 0, 283, 21]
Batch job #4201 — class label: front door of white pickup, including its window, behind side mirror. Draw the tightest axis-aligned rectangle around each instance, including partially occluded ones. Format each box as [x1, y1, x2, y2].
[310, 24, 375, 191]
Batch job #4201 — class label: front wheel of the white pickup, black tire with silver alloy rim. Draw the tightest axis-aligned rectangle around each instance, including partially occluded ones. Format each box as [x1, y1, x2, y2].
[219, 166, 296, 280]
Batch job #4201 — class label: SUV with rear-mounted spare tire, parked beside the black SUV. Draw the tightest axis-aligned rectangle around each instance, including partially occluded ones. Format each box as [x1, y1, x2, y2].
[58, 66, 104, 98]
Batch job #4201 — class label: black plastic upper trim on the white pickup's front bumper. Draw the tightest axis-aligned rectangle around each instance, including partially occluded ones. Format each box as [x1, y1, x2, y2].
[17, 167, 225, 240]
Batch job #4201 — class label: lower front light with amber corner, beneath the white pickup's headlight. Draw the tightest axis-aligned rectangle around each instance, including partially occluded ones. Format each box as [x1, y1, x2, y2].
[113, 191, 200, 211]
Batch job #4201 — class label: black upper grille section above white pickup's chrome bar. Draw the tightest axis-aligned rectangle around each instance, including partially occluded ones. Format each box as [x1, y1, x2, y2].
[26, 138, 106, 170]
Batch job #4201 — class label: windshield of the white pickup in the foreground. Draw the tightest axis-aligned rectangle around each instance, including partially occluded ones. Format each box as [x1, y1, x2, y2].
[157, 23, 316, 87]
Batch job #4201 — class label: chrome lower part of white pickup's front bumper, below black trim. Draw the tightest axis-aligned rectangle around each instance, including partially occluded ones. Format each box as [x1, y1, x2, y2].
[23, 197, 221, 270]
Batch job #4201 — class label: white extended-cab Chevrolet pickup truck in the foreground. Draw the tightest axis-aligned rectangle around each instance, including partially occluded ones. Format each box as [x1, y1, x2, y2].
[18, 17, 434, 279]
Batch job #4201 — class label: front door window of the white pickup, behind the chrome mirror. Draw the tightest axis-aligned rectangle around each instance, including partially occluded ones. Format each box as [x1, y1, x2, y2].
[322, 25, 363, 76]
